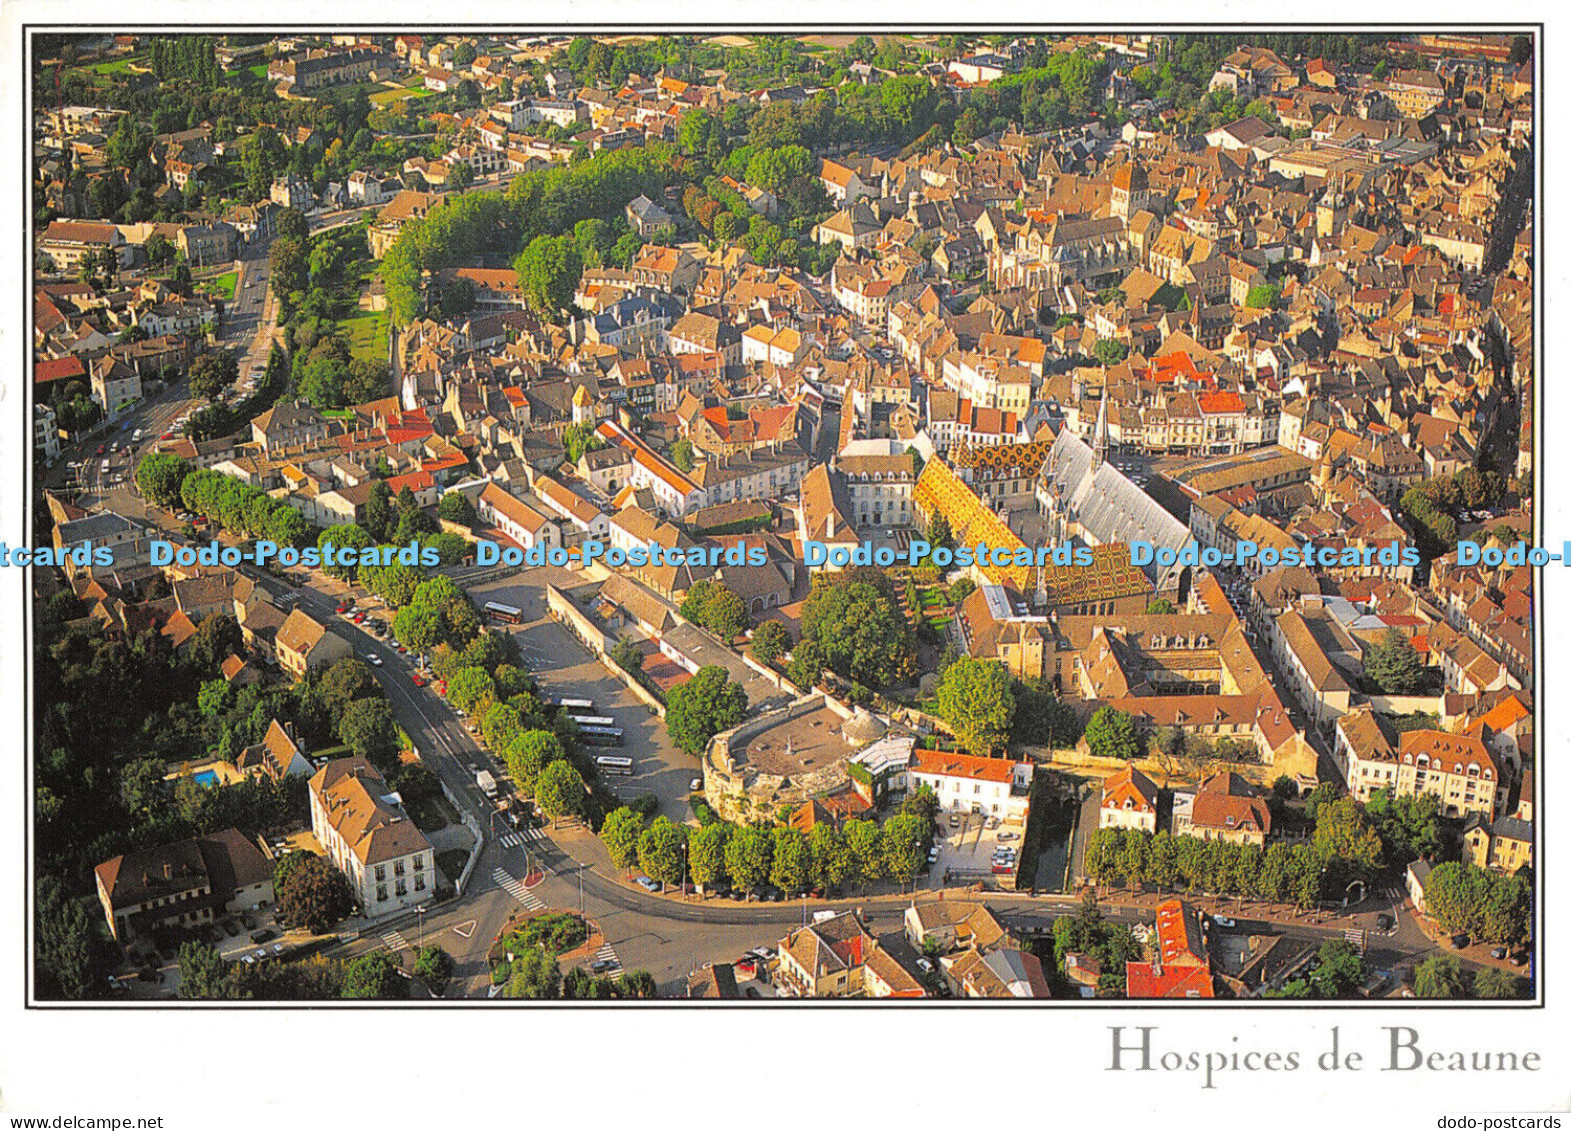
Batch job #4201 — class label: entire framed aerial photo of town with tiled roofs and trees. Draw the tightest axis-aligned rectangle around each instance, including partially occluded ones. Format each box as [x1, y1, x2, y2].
[28, 30, 1541, 1008]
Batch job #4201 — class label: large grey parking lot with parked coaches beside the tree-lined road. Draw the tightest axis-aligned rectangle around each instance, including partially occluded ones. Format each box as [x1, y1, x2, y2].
[470, 567, 702, 822]
